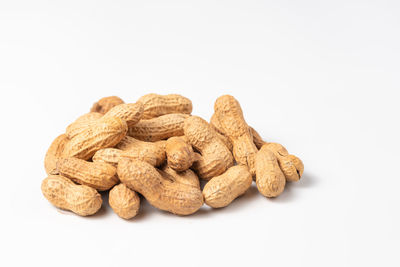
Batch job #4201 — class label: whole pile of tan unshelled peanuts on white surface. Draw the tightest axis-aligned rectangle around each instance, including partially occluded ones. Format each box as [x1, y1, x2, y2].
[41, 94, 304, 219]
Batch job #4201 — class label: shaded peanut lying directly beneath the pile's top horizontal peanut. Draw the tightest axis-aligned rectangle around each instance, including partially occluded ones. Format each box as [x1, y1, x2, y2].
[128, 114, 189, 142]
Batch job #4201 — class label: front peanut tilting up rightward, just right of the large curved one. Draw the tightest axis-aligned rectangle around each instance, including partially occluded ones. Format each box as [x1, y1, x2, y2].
[203, 165, 253, 208]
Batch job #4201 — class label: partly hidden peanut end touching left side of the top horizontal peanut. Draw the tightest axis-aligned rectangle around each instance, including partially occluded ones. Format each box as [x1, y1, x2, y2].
[104, 103, 143, 127]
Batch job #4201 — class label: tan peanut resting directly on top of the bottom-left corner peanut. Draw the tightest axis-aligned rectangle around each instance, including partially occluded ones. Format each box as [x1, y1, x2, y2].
[57, 158, 118, 191]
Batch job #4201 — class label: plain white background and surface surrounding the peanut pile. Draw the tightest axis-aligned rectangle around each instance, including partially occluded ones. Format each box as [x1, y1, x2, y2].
[0, 0, 400, 266]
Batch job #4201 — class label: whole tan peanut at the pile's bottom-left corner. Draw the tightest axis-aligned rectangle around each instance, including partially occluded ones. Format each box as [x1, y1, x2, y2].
[42, 175, 102, 216]
